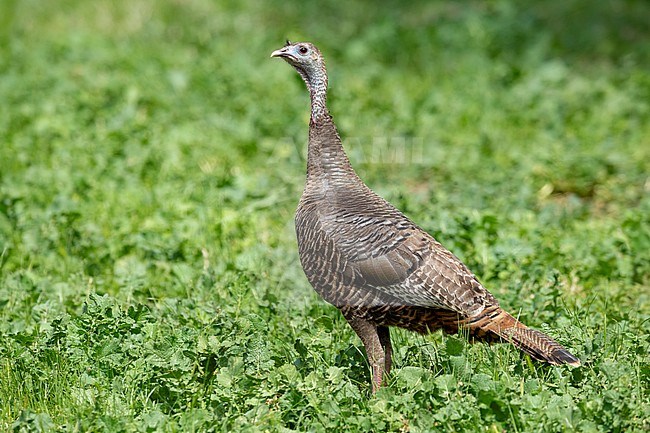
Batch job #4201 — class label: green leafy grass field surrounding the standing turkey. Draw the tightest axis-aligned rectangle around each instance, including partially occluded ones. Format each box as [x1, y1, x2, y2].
[0, 0, 650, 433]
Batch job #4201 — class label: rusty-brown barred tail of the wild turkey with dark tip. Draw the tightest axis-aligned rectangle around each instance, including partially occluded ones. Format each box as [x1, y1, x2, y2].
[466, 306, 580, 367]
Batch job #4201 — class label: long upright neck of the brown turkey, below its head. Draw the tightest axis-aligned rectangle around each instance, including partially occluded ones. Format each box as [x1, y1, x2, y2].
[305, 74, 358, 192]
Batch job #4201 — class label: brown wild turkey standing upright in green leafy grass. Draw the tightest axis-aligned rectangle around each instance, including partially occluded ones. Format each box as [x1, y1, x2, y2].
[271, 41, 580, 392]
